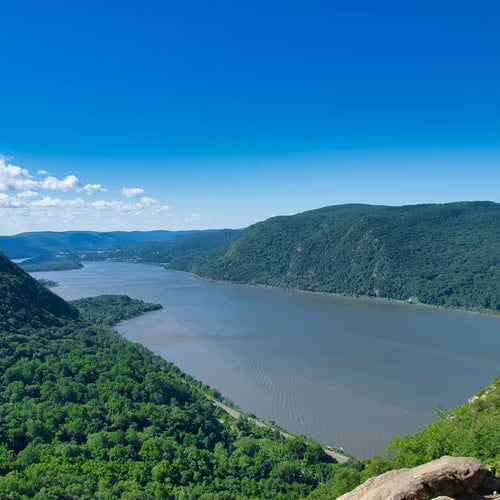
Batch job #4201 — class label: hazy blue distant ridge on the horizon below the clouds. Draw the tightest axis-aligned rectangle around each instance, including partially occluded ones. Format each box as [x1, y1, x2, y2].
[0, 231, 209, 259]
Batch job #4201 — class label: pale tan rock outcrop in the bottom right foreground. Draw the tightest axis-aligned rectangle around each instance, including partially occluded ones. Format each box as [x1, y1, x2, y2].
[339, 456, 500, 500]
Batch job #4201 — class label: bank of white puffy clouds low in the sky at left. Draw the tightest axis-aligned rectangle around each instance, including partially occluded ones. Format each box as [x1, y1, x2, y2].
[0, 156, 171, 234]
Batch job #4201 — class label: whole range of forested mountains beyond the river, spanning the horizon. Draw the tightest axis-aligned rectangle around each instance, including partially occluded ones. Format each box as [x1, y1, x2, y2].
[0, 201, 500, 311]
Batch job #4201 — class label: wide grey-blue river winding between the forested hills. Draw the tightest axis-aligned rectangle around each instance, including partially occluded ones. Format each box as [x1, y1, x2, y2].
[33, 262, 500, 458]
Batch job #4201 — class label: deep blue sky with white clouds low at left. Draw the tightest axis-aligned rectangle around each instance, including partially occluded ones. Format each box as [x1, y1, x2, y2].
[0, 0, 500, 234]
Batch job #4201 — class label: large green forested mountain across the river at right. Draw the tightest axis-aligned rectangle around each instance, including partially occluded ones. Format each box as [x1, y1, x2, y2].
[171, 202, 500, 310]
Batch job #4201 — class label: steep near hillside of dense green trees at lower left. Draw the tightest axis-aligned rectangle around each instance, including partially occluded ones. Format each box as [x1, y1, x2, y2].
[0, 255, 343, 500]
